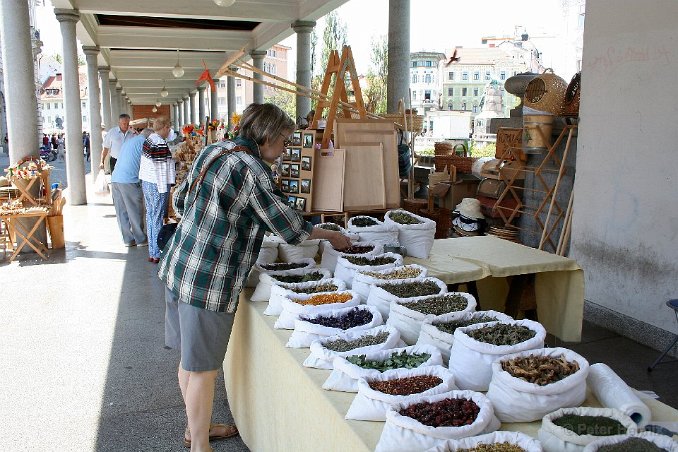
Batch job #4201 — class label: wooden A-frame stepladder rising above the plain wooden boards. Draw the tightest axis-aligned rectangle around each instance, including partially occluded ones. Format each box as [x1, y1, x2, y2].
[309, 46, 368, 149]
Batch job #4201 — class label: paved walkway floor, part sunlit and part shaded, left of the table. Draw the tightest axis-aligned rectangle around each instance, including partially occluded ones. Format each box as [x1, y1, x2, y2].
[0, 176, 247, 452]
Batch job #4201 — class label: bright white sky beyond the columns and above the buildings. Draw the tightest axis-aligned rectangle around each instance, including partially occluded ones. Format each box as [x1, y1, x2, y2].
[36, 0, 574, 77]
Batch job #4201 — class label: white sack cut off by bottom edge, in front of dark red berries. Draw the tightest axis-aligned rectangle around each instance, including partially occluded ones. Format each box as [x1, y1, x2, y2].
[427, 430, 542, 452]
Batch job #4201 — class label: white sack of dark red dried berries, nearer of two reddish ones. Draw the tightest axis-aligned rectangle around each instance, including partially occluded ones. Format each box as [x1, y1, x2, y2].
[375, 391, 501, 452]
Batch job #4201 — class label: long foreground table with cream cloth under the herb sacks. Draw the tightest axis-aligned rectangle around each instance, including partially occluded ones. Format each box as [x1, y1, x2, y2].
[224, 290, 678, 452]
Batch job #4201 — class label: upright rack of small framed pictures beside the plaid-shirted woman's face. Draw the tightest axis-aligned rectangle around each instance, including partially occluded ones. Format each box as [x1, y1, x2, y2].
[280, 130, 315, 212]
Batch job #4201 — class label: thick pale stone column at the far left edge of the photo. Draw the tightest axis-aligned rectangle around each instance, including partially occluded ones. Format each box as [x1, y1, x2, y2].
[0, 0, 42, 164]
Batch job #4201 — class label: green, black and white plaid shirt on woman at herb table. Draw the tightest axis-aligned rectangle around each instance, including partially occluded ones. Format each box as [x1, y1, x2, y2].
[158, 141, 313, 313]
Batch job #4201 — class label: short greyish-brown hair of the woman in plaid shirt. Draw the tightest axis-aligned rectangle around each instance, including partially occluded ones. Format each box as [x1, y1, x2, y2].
[240, 103, 295, 144]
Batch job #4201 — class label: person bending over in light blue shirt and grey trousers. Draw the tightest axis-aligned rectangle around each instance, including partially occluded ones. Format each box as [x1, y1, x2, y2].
[111, 128, 153, 246]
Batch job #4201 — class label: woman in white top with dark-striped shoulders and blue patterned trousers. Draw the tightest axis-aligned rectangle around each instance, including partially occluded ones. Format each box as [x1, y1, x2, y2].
[139, 116, 176, 264]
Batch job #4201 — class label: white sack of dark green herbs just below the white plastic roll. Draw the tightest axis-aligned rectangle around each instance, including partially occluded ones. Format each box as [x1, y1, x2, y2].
[538, 407, 637, 452]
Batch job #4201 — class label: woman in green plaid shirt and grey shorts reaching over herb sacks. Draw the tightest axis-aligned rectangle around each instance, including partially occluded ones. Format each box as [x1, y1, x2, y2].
[159, 104, 351, 451]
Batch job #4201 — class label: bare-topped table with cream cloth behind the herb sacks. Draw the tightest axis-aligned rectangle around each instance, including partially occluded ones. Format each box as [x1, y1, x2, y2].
[404, 236, 584, 342]
